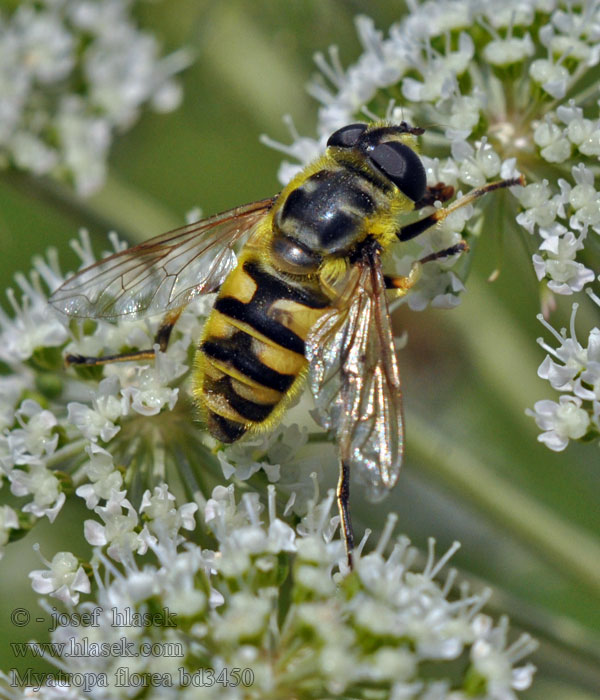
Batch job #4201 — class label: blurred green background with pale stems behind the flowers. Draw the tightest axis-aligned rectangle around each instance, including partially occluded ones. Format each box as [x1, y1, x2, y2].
[0, 0, 600, 700]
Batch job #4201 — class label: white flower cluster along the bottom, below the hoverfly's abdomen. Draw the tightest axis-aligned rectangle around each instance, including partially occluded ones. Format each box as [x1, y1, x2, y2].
[4, 486, 536, 700]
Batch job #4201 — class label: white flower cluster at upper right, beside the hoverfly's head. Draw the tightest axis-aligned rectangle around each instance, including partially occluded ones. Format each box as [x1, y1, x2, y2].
[264, 0, 600, 449]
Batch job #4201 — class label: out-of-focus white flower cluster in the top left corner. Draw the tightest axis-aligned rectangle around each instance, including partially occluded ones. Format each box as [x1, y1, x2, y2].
[0, 0, 190, 194]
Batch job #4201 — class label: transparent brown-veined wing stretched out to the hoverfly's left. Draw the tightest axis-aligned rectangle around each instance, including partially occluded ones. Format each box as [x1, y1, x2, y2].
[50, 198, 274, 319]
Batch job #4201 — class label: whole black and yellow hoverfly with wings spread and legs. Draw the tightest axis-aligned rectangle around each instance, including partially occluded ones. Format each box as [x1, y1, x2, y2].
[50, 122, 523, 567]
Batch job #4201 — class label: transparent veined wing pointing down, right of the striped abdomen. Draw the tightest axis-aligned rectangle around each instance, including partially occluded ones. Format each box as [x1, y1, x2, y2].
[306, 251, 404, 498]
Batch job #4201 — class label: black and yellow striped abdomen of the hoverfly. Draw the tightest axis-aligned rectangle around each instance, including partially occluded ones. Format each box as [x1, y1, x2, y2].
[193, 250, 330, 442]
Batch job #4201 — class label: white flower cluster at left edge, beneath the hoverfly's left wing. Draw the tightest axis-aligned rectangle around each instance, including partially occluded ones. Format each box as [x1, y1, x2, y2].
[0, 232, 214, 549]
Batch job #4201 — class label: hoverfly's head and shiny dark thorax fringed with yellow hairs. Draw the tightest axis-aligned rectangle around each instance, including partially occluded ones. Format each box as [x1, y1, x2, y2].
[268, 123, 426, 275]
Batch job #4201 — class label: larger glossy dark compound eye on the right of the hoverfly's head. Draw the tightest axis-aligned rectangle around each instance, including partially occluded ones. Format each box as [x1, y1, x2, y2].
[369, 141, 427, 202]
